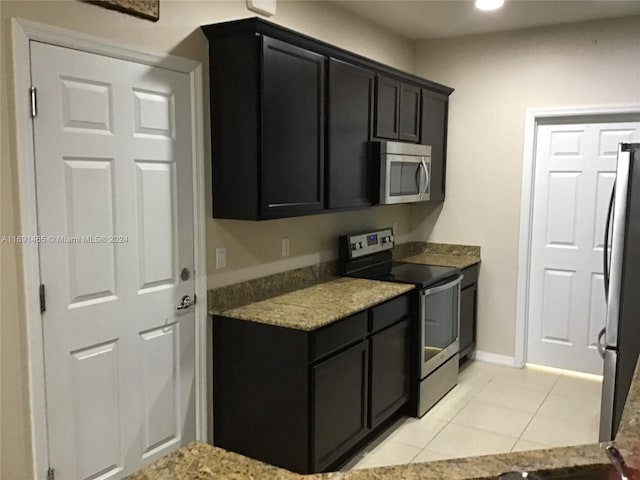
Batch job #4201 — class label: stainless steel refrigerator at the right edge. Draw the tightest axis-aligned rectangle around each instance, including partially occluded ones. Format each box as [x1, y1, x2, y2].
[598, 143, 640, 441]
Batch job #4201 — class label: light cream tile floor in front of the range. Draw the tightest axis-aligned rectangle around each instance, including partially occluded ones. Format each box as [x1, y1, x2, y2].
[344, 361, 602, 470]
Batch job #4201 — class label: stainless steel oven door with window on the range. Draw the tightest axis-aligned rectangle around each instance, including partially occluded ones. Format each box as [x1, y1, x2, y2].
[420, 275, 462, 378]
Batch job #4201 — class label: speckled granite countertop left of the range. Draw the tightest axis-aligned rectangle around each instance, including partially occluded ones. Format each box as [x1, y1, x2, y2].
[222, 278, 413, 330]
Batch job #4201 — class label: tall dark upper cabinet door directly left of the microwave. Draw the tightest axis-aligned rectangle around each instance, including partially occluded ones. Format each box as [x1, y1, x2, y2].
[327, 59, 375, 208]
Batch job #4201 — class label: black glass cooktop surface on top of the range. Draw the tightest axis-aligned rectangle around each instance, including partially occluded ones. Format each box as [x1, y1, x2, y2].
[350, 262, 460, 288]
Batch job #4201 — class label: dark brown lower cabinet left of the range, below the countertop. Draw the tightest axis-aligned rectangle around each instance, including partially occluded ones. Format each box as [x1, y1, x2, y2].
[213, 292, 416, 473]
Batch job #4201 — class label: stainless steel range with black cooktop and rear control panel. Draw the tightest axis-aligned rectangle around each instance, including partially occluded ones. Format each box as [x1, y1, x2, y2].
[339, 228, 462, 417]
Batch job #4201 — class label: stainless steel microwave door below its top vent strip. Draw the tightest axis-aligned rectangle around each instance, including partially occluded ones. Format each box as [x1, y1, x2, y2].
[380, 154, 431, 204]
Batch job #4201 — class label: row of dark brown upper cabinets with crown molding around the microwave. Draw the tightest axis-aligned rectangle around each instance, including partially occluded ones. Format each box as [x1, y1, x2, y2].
[202, 18, 453, 220]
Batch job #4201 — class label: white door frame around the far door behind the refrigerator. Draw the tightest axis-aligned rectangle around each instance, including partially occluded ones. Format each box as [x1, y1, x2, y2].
[515, 104, 640, 367]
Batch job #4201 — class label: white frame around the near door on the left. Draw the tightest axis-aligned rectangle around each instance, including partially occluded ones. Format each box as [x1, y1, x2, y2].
[11, 18, 207, 478]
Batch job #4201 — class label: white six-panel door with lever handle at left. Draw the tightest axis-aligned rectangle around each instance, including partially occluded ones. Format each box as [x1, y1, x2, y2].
[30, 42, 195, 479]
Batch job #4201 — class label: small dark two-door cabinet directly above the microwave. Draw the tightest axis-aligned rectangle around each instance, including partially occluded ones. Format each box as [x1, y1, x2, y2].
[375, 75, 420, 142]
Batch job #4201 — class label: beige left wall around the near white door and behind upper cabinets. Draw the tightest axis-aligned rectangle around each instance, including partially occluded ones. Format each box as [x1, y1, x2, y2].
[0, 0, 415, 479]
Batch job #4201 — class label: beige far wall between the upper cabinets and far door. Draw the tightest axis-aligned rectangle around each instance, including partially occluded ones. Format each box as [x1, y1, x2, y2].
[413, 17, 640, 356]
